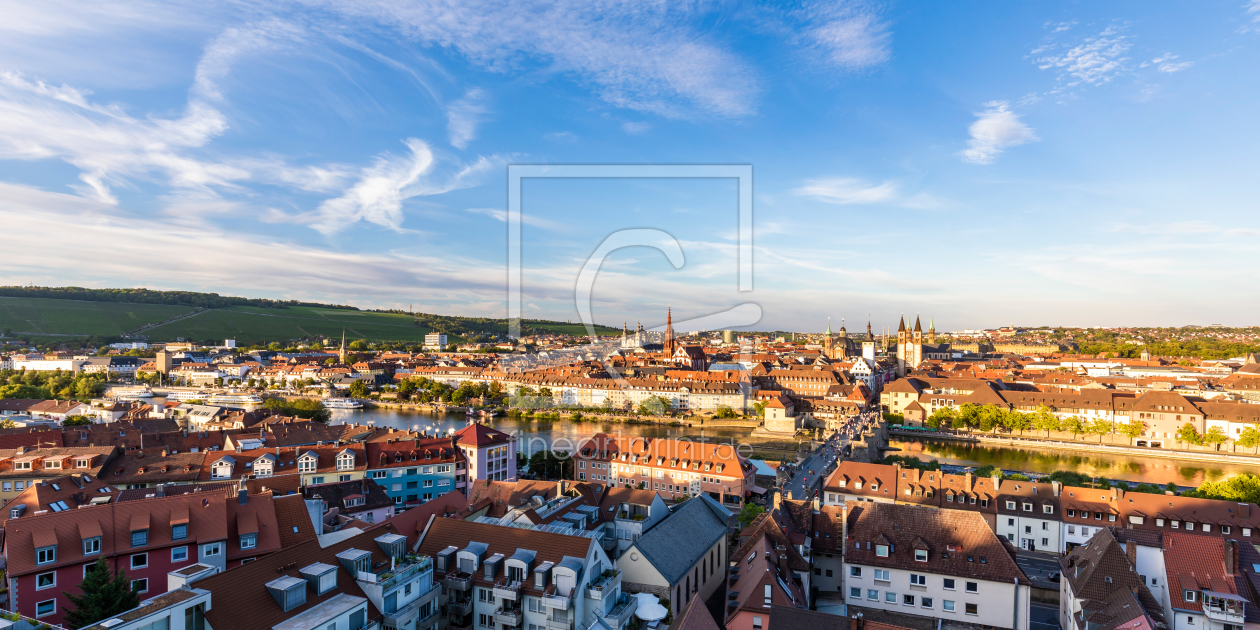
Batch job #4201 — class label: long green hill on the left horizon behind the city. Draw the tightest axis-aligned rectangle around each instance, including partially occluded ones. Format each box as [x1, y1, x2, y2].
[0, 287, 619, 345]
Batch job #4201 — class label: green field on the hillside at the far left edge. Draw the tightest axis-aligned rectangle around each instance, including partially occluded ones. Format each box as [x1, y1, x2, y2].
[0, 297, 194, 336]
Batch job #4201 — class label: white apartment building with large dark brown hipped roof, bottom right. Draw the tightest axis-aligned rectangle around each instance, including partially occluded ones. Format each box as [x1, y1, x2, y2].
[844, 501, 1031, 629]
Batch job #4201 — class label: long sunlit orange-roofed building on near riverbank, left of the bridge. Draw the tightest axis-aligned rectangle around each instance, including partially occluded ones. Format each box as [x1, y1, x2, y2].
[575, 433, 750, 508]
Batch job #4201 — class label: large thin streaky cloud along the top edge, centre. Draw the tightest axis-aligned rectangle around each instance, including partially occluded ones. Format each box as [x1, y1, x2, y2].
[312, 0, 759, 117]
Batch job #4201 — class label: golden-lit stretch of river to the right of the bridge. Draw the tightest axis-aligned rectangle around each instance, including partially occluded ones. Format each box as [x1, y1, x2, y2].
[890, 441, 1260, 486]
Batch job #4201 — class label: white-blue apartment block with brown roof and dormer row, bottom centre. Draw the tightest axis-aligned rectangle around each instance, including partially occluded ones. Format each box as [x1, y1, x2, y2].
[418, 519, 638, 630]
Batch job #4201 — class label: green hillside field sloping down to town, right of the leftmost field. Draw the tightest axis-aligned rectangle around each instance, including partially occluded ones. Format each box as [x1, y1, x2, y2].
[145, 306, 428, 344]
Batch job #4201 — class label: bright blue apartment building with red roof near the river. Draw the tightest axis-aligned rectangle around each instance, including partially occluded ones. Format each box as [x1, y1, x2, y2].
[367, 437, 469, 510]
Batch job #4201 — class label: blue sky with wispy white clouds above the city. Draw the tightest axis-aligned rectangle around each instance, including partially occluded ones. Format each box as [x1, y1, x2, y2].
[0, 0, 1260, 330]
